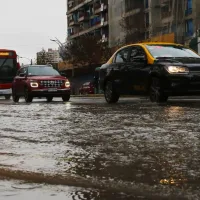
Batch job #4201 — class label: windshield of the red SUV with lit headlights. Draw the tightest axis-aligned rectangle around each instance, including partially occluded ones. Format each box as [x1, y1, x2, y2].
[28, 66, 60, 76]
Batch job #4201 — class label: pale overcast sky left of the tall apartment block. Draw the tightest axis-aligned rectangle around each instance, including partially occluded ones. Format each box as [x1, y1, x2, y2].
[0, 0, 67, 64]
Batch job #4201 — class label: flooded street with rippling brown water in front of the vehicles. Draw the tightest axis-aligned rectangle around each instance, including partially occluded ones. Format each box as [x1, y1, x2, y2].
[0, 98, 200, 200]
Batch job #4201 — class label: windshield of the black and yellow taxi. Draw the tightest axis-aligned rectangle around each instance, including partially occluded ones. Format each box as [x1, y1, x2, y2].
[146, 44, 200, 58]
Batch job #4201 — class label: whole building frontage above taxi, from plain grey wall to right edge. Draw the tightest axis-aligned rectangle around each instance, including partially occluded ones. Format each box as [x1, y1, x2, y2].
[108, 0, 200, 46]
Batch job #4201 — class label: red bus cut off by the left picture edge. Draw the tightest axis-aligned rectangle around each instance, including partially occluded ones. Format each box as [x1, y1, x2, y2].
[0, 49, 20, 100]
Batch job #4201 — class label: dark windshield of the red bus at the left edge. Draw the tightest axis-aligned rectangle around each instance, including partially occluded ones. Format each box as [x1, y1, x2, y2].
[0, 58, 17, 78]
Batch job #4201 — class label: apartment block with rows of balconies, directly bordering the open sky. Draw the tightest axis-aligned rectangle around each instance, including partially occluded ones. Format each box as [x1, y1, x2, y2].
[66, 0, 109, 42]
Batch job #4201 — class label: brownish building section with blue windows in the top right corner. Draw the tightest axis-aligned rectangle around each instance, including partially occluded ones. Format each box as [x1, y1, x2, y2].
[140, 0, 200, 44]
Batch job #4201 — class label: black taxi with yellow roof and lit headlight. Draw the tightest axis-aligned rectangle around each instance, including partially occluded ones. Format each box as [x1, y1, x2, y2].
[99, 43, 200, 103]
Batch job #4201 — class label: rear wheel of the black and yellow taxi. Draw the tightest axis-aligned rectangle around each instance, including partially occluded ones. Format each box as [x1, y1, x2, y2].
[104, 81, 119, 103]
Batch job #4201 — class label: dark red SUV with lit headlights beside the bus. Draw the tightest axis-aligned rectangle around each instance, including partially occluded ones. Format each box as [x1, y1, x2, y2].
[12, 65, 70, 102]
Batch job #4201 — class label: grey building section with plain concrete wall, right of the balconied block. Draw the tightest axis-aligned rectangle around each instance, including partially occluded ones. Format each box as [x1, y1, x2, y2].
[108, 0, 145, 47]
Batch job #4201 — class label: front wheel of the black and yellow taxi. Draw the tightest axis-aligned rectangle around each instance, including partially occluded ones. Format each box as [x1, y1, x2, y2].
[149, 78, 168, 103]
